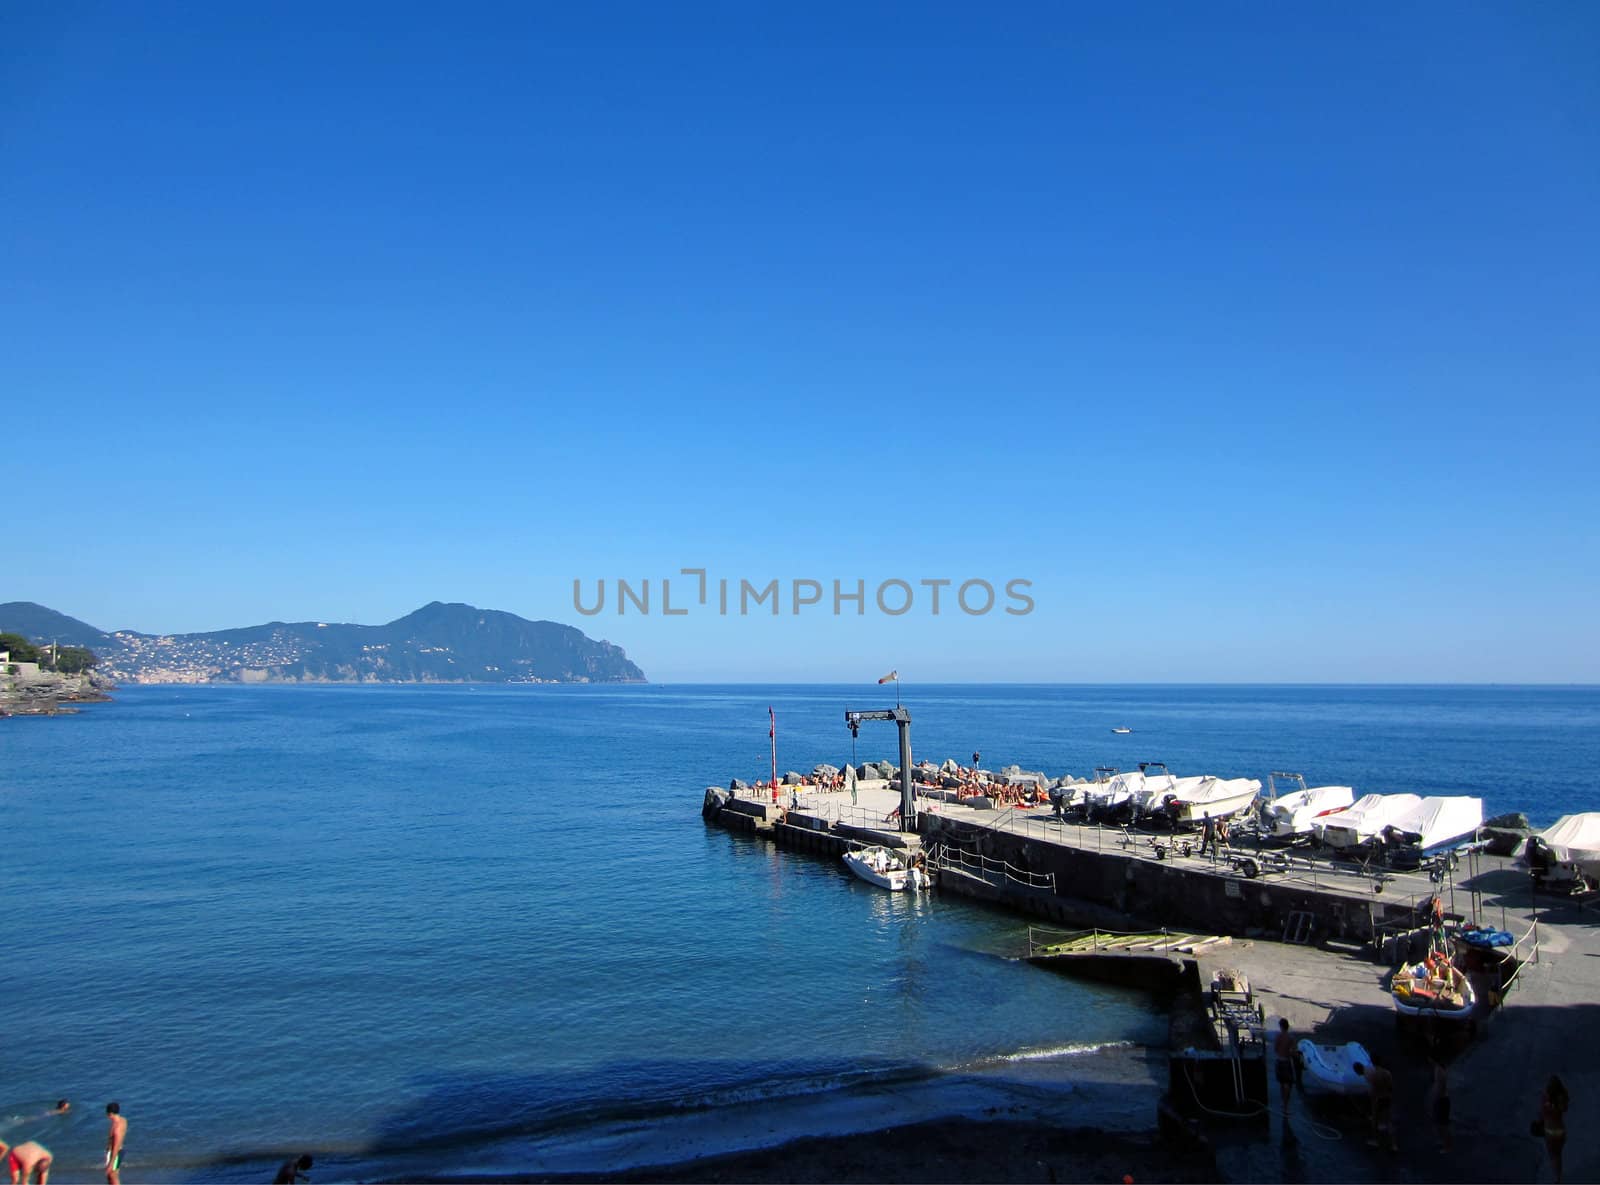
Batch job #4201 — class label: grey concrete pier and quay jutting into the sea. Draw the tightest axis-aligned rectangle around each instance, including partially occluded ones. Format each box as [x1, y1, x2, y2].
[706, 767, 1600, 1182]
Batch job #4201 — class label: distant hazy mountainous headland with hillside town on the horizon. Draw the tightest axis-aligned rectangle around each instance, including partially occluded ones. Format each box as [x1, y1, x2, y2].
[0, 601, 646, 683]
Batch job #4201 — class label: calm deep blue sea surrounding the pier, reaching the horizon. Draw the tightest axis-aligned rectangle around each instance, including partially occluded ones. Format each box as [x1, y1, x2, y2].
[0, 684, 1600, 1182]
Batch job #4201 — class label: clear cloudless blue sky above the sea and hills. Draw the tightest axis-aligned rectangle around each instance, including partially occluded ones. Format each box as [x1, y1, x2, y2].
[0, 0, 1600, 681]
